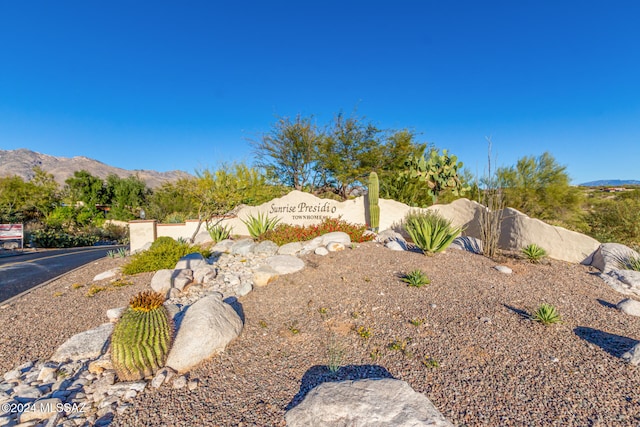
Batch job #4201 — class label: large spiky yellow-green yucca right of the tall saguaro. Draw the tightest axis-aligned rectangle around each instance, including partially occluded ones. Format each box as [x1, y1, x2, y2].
[404, 211, 462, 255]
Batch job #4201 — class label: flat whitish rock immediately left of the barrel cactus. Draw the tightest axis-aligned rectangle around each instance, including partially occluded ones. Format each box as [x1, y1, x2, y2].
[51, 323, 114, 362]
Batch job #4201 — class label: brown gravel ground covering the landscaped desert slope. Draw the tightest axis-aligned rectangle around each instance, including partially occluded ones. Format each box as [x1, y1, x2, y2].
[0, 243, 640, 426]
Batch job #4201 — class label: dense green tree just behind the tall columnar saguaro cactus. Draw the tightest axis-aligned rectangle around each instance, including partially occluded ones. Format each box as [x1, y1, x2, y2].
[318, 113, 384, 199]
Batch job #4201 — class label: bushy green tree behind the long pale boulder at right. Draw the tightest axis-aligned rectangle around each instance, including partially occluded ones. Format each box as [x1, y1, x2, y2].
[496, 152, 582, 228]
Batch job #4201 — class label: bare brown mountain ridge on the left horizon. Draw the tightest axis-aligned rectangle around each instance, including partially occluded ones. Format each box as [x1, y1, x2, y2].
[0, 148, 191, 188]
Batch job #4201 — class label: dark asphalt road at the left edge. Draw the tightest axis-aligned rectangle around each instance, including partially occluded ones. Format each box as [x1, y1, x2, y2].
[0, 246, 121, 302]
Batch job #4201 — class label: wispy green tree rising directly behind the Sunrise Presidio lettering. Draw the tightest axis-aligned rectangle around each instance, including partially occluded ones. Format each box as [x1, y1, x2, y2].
[251, 114, 323, 192]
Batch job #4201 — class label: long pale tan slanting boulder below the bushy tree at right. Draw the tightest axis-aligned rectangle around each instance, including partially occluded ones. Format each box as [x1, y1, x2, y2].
[498, 208, 600, 264]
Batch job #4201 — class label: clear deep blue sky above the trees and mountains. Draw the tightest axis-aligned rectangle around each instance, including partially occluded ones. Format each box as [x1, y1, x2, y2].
[0, 0, 640, 183]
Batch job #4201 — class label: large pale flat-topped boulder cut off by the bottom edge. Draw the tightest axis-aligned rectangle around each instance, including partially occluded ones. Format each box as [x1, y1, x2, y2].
[284, 378, 453, 427]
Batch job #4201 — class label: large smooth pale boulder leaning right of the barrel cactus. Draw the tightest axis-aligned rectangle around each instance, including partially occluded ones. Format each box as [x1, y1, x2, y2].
[166, 294, 243, 372]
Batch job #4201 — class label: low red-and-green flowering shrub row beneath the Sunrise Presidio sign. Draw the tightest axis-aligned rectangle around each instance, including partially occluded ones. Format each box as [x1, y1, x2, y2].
[260, 218, 375, 246]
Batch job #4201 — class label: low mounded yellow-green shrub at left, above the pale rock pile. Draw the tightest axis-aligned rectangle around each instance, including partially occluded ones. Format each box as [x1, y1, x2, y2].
[122, 236, 210, 274]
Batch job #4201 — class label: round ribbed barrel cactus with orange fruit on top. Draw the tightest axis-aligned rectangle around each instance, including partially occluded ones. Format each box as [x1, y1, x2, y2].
[111, 291, 173, 381]
